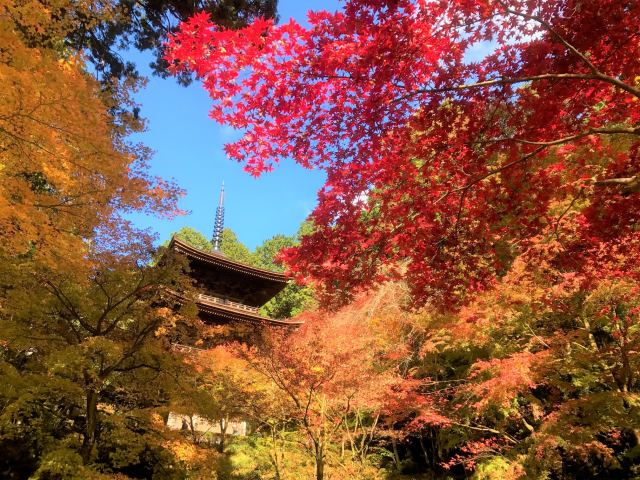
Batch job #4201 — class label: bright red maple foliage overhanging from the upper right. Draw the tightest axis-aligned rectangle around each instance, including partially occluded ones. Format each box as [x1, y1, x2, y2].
[168, 0, 640, 304]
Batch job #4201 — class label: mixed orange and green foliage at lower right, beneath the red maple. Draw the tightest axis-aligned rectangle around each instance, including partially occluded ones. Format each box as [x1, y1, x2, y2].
[360, 248, 640, 478]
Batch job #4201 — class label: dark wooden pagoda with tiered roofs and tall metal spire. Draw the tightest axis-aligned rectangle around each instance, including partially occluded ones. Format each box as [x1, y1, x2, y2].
[169, 183, 302, 326]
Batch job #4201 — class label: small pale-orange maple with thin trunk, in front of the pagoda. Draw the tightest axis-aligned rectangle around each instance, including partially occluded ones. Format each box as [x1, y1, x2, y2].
[242, 308, 396, 480]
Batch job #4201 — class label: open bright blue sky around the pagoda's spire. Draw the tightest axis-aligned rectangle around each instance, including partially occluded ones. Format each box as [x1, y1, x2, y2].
[128, 0, 339, 248]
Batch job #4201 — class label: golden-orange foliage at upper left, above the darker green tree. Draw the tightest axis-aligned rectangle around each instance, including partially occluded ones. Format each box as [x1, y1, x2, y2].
[0, 0, 178, 271]
